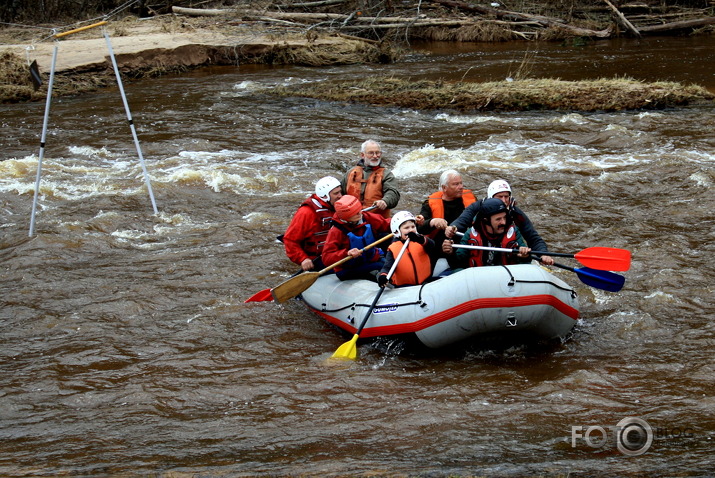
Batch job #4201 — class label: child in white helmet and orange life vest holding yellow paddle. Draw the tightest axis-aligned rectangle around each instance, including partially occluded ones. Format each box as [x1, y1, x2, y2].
[377, 211, 435, 287]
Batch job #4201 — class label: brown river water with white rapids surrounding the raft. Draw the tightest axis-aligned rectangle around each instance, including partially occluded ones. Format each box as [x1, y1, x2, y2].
[0, 37, 715, 477]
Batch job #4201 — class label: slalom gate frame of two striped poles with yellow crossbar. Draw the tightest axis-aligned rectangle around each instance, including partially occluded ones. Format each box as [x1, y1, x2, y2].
[29, 21, 159, 237]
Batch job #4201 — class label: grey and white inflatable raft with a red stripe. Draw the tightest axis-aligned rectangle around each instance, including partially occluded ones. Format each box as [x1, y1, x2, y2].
[301, 264, 579, 349]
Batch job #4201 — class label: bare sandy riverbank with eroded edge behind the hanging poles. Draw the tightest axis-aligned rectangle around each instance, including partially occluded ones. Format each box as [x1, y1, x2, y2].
[0, 16, 398, 103]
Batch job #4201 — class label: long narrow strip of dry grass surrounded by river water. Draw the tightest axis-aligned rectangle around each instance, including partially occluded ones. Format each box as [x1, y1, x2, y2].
[273, 78, 715, 112]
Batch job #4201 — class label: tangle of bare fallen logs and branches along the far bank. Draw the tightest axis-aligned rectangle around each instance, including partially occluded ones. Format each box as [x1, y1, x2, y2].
[172, 0, 715, 41]
